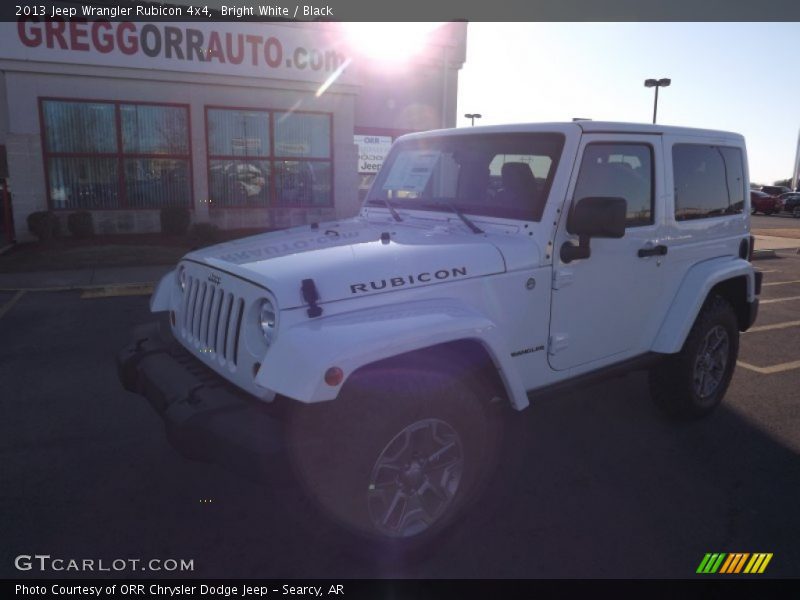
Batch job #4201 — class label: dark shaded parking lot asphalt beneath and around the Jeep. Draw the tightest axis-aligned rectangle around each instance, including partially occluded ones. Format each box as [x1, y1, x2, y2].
[0, 252, 800, 579]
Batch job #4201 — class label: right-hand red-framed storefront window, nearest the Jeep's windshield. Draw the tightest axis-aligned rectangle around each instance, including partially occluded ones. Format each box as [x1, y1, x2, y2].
[206, 108, 332, 208]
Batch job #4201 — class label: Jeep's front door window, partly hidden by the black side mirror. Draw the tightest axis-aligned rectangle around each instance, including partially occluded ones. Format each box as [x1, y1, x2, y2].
[575, 143, 653, 227]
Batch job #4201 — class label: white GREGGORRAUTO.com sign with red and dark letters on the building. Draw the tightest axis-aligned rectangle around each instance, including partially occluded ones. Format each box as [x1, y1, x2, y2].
[0, 17, 353, 83]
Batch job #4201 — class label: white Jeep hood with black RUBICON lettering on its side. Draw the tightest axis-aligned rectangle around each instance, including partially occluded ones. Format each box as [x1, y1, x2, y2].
[185, 219, 505, 309]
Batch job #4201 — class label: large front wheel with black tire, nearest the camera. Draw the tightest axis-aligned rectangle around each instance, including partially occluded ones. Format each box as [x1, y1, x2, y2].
[287, 366, 502, 558]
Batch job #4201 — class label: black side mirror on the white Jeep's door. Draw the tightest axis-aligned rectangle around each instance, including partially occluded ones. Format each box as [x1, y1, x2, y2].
[561, 196, 628, 263]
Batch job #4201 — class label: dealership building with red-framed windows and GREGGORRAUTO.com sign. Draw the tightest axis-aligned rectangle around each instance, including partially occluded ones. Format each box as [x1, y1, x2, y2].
[0, 18, 466, 246]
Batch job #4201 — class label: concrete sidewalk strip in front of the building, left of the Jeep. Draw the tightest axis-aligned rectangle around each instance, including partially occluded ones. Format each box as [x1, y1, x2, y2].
[0, 265, 173, 291]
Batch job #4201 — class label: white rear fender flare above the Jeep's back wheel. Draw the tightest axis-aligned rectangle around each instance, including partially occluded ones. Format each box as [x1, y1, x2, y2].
[653, 256, 756, 354]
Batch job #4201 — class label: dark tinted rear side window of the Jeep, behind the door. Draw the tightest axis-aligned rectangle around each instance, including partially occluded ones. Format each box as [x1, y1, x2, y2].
[672, 144, 745, 221]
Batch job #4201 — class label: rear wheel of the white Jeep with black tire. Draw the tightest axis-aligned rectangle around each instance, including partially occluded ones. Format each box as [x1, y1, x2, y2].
[649, 295, 739, 419]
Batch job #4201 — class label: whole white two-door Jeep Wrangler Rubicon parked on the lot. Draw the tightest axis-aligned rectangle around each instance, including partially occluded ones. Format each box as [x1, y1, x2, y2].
[118, 121, 761, 546]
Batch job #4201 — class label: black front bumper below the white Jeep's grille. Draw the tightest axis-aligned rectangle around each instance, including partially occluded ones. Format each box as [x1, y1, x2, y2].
[117, 323, 285, 471]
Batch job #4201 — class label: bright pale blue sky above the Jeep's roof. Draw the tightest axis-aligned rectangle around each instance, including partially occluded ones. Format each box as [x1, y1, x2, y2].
[458, 23, 800, 184]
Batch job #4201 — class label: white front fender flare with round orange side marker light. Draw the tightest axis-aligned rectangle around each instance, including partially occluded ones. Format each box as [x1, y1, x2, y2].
[256, 299, 528, 410]
